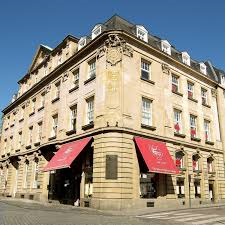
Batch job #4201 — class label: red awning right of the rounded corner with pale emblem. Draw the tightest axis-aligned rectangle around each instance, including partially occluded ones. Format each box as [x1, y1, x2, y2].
[134, 137, 179, 174]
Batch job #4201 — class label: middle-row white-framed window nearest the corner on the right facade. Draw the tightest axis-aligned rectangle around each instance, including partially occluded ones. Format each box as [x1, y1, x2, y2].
[141, 98, 152, 126]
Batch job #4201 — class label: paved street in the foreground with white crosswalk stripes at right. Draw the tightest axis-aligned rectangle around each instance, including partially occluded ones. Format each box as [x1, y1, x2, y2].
[0, 200, 225, 225]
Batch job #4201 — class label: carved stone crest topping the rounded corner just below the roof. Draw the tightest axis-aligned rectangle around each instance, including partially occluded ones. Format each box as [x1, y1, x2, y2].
[97, 34, 133, 66]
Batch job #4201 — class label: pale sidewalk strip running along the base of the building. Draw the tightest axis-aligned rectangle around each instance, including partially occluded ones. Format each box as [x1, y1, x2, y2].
[0, 197, 225, 216]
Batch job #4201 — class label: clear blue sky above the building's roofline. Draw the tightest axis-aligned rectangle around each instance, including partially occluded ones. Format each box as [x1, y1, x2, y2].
[0, 0, 225, 115]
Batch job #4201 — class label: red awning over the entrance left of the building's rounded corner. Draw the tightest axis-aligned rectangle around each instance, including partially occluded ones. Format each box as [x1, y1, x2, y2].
[43, 137, 92, 172]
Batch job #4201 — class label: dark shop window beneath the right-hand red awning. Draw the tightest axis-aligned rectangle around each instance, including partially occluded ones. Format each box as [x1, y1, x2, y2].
[140, 173, 157, 198]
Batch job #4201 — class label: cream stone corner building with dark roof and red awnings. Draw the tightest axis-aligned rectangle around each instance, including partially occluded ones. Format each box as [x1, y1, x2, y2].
[0, 15, 225, 210]
